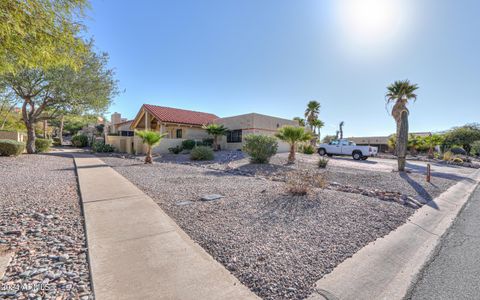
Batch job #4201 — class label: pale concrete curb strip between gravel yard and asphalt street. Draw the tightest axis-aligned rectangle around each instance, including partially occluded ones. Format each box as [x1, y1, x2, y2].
[307, 170, 480, 300]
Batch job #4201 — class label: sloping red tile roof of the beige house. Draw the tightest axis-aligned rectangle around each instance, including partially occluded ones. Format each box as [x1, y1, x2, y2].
[143, 104, 218, 125]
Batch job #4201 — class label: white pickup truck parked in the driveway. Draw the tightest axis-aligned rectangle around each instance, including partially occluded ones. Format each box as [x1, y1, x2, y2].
[318, 139, 378, 160]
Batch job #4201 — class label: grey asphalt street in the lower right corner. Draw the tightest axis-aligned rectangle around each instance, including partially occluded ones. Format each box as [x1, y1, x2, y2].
[408, 187, 480, 300]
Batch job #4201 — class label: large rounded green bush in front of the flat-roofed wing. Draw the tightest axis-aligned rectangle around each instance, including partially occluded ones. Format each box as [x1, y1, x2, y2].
[243, 134, 278, 164]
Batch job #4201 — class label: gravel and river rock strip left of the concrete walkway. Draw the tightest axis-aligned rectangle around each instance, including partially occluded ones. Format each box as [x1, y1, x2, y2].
[0, 155, 93, 300]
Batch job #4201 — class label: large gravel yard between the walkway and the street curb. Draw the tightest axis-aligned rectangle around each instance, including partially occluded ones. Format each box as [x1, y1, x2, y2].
[102, 157, 415, 299]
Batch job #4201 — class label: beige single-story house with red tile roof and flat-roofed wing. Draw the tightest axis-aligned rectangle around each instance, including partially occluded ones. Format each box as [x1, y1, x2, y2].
[106, 104, 298, 154]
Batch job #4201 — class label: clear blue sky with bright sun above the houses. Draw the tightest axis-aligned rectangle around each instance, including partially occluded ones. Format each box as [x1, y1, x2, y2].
[85, 0, 480, 136]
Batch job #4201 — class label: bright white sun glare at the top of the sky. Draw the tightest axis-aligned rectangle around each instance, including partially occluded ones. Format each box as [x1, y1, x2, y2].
[336, 0, 406, 46]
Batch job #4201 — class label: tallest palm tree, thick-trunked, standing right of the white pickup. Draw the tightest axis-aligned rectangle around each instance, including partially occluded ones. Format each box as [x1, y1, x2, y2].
[385, 79, 418, 172]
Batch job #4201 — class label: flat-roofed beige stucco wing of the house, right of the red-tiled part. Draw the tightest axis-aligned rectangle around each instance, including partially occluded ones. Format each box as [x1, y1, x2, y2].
[215, 113, 298, 152]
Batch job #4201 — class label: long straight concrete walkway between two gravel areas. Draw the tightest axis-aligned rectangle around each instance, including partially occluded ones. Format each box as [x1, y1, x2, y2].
[74, 153, 258, 300]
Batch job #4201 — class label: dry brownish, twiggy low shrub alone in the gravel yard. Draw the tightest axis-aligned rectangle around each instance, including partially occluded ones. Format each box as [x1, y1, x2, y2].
[286, 170, 327, 196]
